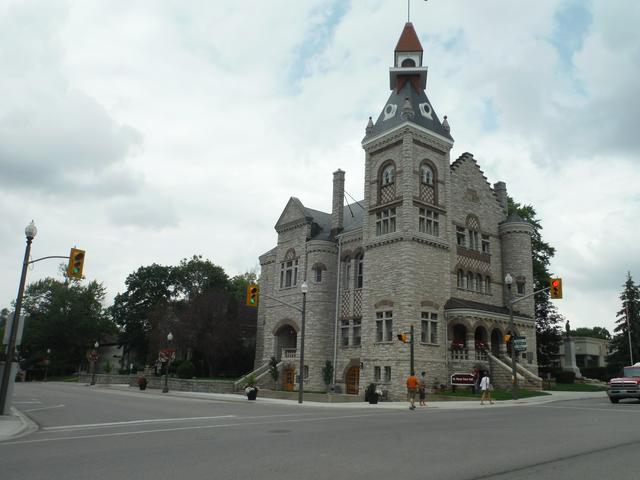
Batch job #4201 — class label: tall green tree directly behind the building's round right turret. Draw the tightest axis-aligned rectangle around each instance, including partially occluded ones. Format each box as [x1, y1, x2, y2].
[508, 198, 564, 367]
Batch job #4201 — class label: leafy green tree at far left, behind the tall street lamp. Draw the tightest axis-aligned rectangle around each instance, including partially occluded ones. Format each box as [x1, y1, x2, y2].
[20, 278, 116, 374]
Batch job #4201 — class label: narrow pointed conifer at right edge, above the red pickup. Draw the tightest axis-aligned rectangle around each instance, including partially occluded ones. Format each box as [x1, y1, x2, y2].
[609, 272, 640, 369]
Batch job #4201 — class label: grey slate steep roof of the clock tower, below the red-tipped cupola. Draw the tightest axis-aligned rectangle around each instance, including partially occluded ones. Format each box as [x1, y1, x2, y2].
[365, 81, 453, 140]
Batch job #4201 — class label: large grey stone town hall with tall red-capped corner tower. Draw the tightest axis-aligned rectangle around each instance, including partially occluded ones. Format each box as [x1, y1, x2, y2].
[256, 23, 539, 398]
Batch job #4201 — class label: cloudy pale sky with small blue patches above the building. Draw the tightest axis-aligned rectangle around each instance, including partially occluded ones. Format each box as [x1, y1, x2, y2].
[0, 0, 640, 328]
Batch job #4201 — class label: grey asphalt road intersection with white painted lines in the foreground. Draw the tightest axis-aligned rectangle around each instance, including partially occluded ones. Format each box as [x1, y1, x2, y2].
[0, 383, 640, 480]
